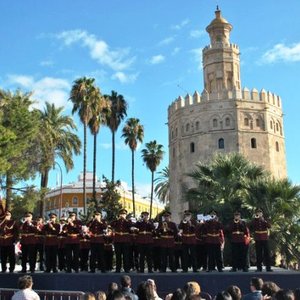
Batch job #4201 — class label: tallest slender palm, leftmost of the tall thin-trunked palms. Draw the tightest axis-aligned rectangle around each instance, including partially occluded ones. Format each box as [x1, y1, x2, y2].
[70, 77, 96, 214]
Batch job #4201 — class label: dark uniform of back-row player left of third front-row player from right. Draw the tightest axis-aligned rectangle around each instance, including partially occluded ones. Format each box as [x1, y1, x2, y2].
[196, 223, 207, 271]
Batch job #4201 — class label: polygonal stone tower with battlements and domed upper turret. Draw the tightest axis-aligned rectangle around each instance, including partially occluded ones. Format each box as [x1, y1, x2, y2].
[168, 8, 287, 221]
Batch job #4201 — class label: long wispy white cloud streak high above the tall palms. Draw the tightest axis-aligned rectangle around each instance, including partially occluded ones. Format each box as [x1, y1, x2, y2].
[56, 29, 135, 71]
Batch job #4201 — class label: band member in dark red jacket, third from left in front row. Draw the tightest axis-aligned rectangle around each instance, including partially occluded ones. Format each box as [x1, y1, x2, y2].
[43, 213, 60, 273]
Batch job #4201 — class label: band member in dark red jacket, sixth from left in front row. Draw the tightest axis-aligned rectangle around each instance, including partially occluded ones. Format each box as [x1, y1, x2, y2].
[111, 209, 132, 273]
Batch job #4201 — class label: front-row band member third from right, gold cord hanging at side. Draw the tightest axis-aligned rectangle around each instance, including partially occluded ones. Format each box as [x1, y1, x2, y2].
[205, 210, 224, 272]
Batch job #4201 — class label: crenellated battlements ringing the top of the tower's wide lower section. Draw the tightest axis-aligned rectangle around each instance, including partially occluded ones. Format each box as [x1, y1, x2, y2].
[168, 87, 281, 116]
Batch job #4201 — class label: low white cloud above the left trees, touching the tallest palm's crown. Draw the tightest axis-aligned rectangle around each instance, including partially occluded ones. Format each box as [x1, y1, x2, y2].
[7, 74, 71, 109]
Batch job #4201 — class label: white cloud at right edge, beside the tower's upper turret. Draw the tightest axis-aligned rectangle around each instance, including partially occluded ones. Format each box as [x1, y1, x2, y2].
[261, 43, 300, 63]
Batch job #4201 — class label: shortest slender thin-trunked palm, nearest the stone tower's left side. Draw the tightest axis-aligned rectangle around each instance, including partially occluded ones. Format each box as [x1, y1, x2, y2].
[142, 140, 164, 219]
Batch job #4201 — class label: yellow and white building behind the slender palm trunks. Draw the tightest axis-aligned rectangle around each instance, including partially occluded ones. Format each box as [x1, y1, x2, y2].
[44, 172, 164, 217]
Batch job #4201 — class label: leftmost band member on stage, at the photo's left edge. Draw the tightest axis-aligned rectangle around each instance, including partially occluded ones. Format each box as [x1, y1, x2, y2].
[0, 210, 18, 273]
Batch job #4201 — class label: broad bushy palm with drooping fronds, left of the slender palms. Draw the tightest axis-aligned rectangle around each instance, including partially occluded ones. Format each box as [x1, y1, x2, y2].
[38, 102, 81, 215]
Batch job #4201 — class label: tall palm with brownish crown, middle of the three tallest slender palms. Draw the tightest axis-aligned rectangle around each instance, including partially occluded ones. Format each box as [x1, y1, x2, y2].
[89, 88, 110, 201]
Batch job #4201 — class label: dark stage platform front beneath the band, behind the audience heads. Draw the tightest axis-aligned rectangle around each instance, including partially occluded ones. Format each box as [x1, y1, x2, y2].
[0, 268, 300, 297]
